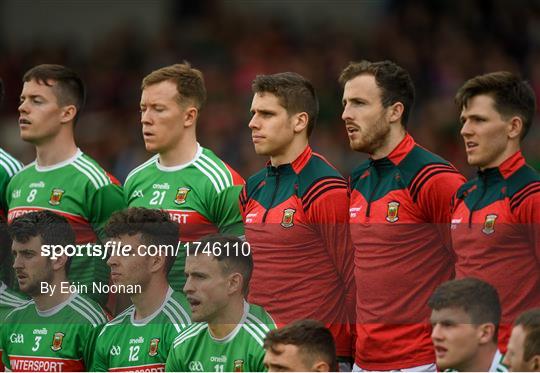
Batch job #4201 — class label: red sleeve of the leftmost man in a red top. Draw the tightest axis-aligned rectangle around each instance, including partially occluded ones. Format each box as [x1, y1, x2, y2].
[302, 177, 356, 323]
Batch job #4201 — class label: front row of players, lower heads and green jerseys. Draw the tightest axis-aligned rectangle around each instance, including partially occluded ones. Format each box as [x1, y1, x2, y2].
[0, 208, 540, 372]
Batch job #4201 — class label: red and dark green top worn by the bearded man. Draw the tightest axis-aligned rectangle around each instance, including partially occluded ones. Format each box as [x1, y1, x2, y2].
[349, 134, 465, 370]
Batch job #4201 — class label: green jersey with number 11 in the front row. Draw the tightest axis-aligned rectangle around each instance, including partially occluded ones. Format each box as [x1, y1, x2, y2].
[165, 302, 276, 372]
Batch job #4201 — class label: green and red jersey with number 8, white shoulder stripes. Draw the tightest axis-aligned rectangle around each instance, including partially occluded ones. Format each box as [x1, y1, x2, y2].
[7, 149, 125, 299]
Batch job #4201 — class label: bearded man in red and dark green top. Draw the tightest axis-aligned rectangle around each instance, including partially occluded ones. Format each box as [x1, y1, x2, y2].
[339, 61, 465, 371]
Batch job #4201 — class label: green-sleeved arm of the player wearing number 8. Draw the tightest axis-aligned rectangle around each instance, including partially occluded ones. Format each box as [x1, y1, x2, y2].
[87, 177, 127, 241]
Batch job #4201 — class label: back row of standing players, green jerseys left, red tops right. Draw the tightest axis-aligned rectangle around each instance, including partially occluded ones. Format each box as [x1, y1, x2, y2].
[0, 61, 540, 370]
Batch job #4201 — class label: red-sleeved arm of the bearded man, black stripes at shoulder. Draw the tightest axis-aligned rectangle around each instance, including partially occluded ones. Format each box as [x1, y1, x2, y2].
[409, 163, 466, 256]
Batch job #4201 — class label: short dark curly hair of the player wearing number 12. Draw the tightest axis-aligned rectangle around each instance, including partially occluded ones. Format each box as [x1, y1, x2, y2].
[104, 207, 179, 273]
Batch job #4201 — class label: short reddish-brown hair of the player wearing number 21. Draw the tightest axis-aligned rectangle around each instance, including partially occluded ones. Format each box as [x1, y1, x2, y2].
[141, 61, 206, 110]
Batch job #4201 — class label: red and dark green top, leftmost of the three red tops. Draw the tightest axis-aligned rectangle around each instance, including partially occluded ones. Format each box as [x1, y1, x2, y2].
[240, 146, 355, 356]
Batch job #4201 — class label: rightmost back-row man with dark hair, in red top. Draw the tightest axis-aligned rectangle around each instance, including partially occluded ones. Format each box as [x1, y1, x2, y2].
[451, 71, 540, 351]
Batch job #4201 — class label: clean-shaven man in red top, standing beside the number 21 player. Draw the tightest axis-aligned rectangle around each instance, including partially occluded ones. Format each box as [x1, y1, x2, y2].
[240, 73, 355, 369]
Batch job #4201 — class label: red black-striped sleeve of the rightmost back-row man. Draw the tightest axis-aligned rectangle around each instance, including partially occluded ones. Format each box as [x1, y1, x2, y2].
[510, 181, 540, 263]
